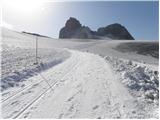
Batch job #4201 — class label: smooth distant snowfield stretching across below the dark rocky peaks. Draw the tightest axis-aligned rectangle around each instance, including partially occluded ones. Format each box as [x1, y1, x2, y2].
[2, 29, 159, 65]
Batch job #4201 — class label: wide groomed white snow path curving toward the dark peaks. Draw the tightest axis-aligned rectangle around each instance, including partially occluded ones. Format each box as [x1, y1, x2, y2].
[2, 50, 158, 118]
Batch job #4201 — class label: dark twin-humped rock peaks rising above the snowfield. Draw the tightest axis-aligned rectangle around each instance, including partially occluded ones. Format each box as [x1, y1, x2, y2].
[59, 17, 134, 40]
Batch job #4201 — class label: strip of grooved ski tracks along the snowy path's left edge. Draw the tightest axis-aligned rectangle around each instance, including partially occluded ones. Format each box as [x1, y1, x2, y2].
[2, 50, 78, 118]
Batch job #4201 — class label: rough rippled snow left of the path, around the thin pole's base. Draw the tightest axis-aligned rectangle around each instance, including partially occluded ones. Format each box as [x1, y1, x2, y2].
[1, 45, 69, 91]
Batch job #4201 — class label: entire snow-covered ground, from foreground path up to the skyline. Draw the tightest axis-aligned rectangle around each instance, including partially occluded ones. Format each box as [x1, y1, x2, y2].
[1, 29, 159, 119]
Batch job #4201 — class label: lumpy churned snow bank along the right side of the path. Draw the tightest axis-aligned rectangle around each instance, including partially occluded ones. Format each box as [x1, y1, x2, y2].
[105, 56, 159, 117]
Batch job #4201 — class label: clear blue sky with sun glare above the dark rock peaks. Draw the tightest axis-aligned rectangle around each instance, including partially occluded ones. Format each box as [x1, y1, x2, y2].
[3, 1, 159, 40]
